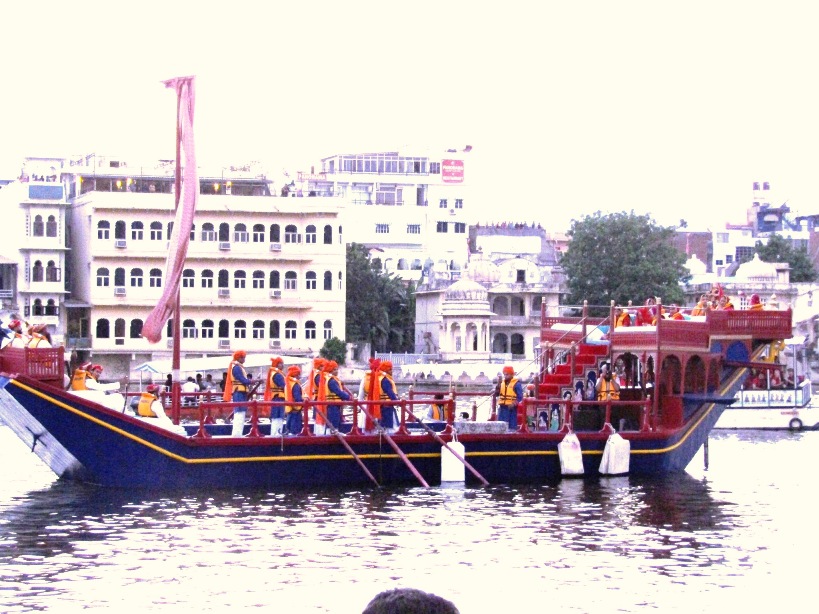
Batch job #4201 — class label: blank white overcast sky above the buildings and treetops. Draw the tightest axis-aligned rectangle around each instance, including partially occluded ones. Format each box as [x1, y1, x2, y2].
[0, 0, 819, 231]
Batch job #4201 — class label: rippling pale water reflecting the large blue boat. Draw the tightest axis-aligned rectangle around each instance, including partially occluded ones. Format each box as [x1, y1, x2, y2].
[0, 427, 819, 613]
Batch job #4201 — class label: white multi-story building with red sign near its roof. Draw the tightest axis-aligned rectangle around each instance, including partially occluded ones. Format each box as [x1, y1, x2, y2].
[296, 147, 472, 283]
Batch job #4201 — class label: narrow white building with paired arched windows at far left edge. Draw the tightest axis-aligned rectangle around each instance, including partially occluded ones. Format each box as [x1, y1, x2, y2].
[0, 158, 68, 343]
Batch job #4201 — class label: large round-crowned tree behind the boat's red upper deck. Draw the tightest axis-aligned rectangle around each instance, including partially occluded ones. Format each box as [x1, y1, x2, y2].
[560, 211, 690, 307]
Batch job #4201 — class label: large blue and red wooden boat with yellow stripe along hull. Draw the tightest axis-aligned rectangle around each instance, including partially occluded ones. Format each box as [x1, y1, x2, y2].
[0, 78, 792, 490]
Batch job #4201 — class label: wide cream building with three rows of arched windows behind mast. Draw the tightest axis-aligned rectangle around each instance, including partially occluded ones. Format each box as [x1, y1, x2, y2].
[64, 156, 346, 373]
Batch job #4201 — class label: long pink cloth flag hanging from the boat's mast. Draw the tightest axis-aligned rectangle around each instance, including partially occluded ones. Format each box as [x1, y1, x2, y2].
[142, 77, 199, 343]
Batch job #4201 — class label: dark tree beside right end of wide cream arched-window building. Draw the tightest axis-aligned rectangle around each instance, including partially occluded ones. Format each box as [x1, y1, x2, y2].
[346, 243, 415, 352]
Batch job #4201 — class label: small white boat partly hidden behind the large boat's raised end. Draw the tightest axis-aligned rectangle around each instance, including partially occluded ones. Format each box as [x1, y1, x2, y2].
[714, 337, 819, 431]
